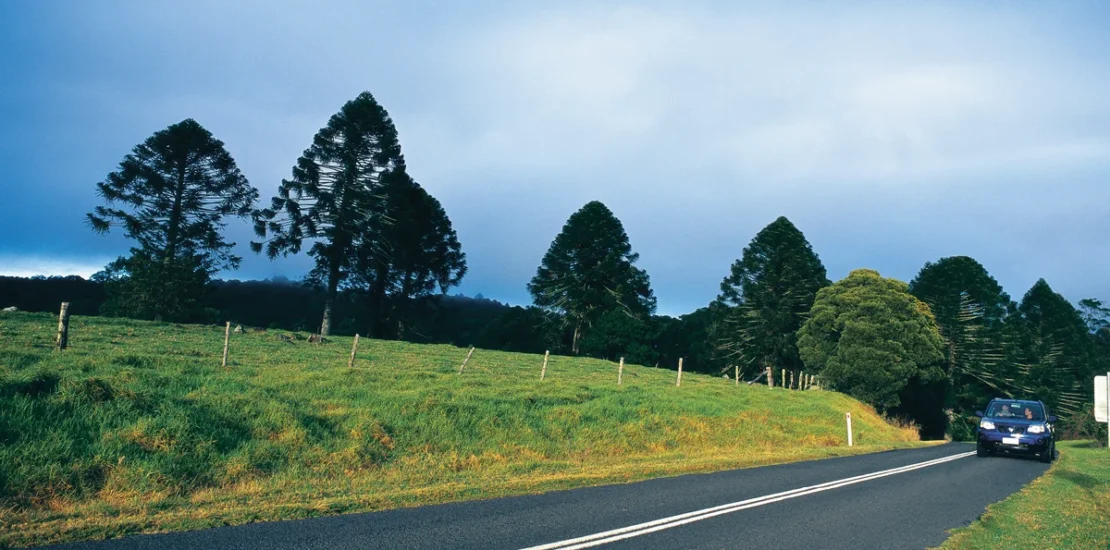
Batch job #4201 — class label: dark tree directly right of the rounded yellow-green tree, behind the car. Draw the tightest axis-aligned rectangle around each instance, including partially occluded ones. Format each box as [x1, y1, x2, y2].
[904, 256, 1012, 437]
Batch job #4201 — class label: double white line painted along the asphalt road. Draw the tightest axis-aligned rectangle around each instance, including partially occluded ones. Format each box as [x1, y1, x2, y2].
[524, 451, 975, 550]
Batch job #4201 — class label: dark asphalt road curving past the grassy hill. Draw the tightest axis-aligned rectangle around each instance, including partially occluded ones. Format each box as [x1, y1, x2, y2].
[45, 443, 1047, 550]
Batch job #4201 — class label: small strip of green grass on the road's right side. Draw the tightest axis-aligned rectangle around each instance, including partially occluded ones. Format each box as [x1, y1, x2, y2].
[940, 441, 1110, 550]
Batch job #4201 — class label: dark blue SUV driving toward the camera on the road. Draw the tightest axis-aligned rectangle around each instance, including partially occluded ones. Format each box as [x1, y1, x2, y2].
[976, 399, 1057, 462]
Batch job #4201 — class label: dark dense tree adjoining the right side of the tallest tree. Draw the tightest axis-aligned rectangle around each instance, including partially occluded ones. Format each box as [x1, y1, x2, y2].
[356, 170, 466, 338]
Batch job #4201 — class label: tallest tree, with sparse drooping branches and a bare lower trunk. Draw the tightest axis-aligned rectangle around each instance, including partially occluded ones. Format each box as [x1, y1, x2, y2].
[251, 92, 404, 336]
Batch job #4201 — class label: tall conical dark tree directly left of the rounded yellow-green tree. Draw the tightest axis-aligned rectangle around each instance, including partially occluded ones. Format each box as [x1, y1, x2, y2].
[716, 217, 829, 371]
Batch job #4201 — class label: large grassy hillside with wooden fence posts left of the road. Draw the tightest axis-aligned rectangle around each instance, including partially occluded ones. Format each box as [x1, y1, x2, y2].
[0, 313, 919, 546]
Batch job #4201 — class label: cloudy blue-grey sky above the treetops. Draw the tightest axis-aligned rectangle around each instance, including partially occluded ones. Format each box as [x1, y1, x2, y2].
[0, 0, 1110, 314]
